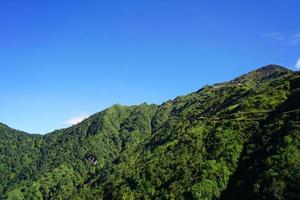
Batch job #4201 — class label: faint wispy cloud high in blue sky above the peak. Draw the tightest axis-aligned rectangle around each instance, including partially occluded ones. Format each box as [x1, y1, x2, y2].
[263, 32, 300, 47]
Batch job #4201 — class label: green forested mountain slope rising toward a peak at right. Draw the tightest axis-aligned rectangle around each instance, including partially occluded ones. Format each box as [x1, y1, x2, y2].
[0, 65, 300, 200]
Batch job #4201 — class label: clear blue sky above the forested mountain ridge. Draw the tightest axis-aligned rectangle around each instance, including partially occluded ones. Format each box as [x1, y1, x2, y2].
[0, 0, 300, 133]
